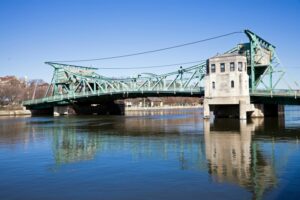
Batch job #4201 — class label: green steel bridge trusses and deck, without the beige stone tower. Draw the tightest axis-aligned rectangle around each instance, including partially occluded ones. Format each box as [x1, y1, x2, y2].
[23, 30, 300, 113]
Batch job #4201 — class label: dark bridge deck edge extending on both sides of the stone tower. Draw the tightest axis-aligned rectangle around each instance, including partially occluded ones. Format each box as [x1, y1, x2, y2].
[23, 89, 300, 108]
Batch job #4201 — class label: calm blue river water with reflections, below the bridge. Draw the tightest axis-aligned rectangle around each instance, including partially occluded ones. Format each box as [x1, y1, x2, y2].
[0, 106, 300, 200]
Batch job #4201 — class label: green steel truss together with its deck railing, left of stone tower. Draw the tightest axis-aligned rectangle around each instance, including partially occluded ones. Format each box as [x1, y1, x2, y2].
[23, 62, 206, 107]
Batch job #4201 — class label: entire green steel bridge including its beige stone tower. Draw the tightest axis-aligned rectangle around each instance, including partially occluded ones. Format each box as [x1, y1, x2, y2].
[23, 30, 300, 119]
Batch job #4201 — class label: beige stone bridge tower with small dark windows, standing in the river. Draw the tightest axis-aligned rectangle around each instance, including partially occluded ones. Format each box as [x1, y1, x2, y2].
[204, 53, 253, 119]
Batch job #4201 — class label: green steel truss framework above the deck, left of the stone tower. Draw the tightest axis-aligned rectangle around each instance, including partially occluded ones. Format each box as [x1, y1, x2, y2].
[45, 62, 206, 97]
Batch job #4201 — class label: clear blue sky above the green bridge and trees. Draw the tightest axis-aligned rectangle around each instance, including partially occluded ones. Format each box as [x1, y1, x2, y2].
[0, 0, 300, 81]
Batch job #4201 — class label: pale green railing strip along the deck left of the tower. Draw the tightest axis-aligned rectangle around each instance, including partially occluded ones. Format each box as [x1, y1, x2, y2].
[23, 88, 203, 106]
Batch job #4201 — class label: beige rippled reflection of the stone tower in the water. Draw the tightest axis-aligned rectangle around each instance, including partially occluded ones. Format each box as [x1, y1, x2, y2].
[204, 119, 277, 199]
